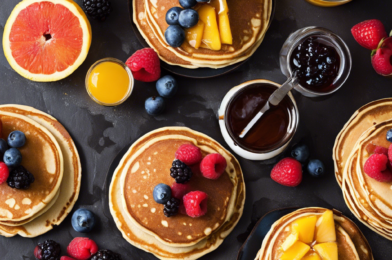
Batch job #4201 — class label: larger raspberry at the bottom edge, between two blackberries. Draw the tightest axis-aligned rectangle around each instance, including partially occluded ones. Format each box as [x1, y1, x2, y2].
[67, 237, 98, 260]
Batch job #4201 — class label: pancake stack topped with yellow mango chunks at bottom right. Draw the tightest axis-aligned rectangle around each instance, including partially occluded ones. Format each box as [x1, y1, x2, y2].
[255, 208, 373, 260]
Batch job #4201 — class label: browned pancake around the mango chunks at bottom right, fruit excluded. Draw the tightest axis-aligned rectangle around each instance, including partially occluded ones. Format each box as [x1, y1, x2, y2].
[255, 208, 373, 260]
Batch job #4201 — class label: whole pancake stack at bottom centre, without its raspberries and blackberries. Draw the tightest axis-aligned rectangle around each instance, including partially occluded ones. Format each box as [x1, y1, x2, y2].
[109, 127, 245, 259]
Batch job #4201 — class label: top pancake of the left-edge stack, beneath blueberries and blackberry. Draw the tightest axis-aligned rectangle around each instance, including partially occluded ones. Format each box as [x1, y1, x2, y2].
[0, 111, 64, 221]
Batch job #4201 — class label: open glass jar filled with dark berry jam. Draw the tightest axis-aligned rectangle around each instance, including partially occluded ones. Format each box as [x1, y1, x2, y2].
[280, 27, 352, 97]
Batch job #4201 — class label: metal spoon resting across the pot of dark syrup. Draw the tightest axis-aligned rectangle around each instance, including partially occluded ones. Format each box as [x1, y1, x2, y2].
[240, 71, 298, 138]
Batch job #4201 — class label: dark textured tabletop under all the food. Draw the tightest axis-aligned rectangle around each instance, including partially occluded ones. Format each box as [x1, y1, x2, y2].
[0, 0, 392, 260]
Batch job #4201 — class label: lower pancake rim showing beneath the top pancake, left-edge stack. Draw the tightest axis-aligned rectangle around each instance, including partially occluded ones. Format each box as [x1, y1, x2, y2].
[0, 105, 81, 237]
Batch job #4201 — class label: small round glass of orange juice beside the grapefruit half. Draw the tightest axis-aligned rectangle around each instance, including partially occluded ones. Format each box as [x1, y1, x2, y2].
[85, 58, 134, 106]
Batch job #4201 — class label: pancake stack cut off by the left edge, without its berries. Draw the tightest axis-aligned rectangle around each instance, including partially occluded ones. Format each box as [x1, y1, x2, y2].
[0, 105, 81, 237]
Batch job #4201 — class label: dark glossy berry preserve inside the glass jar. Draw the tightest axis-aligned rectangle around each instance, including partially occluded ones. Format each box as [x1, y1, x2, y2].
[290, 37, 340, 92]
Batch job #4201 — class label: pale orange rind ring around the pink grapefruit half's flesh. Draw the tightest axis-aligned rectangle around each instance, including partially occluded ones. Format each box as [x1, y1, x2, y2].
[3, 0, 92, 82]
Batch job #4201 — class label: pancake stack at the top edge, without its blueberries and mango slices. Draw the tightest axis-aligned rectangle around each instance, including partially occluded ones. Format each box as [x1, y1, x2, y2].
[133, 0, 272, 69]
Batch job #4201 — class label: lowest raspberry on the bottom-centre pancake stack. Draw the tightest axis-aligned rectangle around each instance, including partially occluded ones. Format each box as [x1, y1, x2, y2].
[184, 191, 208, 218]
